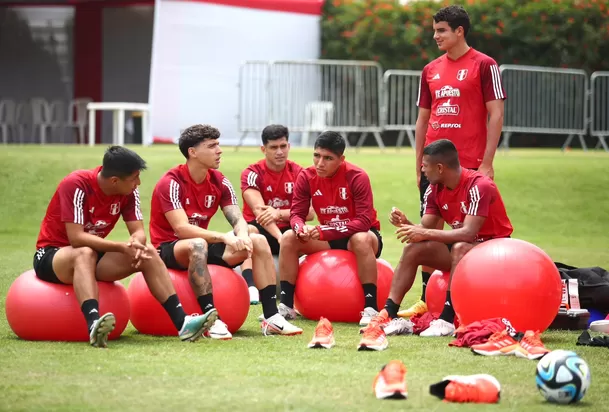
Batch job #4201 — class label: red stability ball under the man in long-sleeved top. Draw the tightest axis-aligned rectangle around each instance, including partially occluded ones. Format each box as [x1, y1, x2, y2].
[294, 250, 393, 322]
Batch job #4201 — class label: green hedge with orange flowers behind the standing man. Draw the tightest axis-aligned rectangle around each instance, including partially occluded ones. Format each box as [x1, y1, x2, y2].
[322, 0, 609, 72]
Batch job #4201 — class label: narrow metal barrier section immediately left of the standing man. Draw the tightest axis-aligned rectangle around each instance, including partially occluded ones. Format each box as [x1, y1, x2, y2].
[383, 70, 421, 149]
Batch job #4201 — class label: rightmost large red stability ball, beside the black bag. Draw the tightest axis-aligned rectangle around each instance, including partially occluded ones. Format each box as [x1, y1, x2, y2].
[451, 239, 562, 332]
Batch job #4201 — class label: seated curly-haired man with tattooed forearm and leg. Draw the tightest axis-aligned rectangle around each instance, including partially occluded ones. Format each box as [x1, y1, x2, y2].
[150, 125, 302, 340]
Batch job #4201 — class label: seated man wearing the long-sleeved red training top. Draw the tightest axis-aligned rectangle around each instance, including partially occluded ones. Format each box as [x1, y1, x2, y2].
[279, 132, 383, 326]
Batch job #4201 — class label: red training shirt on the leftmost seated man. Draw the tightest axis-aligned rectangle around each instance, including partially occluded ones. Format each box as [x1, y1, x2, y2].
[36, 166, 144, 249]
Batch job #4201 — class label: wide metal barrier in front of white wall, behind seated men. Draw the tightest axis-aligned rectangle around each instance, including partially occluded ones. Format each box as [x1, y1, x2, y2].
[238, 60, 385, 149]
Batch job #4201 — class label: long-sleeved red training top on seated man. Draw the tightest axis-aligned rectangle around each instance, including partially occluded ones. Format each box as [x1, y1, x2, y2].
[290, 162, 381, 241]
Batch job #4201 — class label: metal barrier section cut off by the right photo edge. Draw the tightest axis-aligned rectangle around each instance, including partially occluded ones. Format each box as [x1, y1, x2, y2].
[590, 72, 609, 152]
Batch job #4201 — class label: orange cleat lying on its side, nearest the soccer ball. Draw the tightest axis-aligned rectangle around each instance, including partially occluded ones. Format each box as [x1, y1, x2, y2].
[429, 375, 501, 403]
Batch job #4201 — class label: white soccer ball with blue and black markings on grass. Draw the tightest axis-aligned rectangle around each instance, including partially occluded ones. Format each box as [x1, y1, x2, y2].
[535, 350, 590, 404]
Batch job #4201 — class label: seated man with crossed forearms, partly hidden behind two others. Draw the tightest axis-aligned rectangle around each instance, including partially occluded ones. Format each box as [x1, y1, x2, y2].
[241, 124, 313, 304]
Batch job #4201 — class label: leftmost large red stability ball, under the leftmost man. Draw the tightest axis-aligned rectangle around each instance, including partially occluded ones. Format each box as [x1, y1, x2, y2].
[5, 270, 129, 342]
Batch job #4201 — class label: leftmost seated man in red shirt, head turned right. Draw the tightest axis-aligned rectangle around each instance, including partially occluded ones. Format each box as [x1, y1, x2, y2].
[34, 146, 216, 347]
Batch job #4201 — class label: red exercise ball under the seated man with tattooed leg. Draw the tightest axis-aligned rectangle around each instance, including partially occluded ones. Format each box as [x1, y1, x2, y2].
[127, 265, 250, 336]
